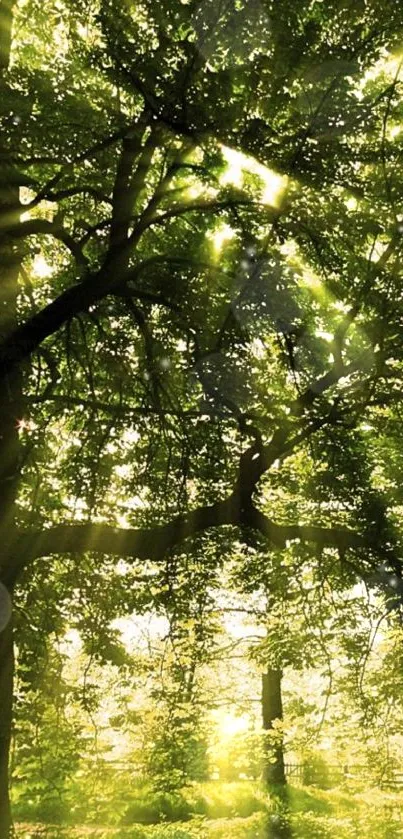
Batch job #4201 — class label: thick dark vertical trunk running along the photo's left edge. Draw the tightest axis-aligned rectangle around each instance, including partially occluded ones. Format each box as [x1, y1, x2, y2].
[0, 0, 22, 839]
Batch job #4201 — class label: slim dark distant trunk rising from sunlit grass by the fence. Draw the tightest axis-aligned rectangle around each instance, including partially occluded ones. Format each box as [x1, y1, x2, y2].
[262, 667, 286, 786]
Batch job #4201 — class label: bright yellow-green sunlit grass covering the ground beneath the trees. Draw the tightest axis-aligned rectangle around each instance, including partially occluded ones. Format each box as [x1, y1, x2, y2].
[12, 782, 403, 839]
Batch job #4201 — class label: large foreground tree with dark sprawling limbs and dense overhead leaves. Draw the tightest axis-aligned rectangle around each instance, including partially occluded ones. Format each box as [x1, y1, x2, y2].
[0, 0, 403, 839]
